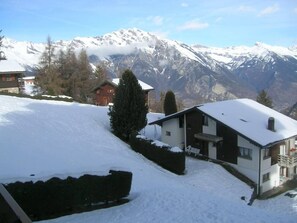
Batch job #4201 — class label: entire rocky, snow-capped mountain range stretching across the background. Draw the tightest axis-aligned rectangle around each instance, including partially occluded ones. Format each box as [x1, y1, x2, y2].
[2, 29, 297, 110]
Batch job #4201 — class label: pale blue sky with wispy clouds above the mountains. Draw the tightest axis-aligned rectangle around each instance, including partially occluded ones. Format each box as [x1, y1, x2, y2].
[0, 0, 297, 47]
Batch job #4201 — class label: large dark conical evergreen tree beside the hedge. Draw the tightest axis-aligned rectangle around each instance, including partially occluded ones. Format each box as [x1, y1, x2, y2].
[109, 70, 148, 140]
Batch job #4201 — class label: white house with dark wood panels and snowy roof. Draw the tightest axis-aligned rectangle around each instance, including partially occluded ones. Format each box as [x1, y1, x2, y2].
[150, 99, 297, 194]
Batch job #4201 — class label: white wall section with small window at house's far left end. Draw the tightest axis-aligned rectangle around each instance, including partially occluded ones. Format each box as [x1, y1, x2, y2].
[162, 118, 185, 149]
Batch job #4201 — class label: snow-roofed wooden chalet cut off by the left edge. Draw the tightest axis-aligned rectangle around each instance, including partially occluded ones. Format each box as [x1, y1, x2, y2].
[0, 60, 25, 94]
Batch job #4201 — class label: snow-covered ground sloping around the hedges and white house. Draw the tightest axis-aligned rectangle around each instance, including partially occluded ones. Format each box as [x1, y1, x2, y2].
[0, 96, 297, 223]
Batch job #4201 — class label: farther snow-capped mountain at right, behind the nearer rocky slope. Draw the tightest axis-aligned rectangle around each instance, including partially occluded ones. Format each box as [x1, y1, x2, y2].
[193, 43, 297, 108]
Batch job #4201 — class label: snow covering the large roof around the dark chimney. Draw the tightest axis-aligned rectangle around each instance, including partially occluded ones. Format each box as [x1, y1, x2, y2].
[197, 99, 297, 146]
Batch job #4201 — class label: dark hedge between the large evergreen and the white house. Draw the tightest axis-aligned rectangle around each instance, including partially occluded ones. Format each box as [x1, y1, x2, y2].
[130, 135, 185, 175]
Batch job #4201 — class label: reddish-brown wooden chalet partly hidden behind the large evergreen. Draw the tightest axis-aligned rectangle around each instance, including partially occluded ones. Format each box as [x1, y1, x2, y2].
[94, 78, 154, 106]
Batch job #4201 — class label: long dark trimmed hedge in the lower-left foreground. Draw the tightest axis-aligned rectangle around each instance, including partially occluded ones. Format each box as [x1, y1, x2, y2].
[5, 170, 132, 220]
